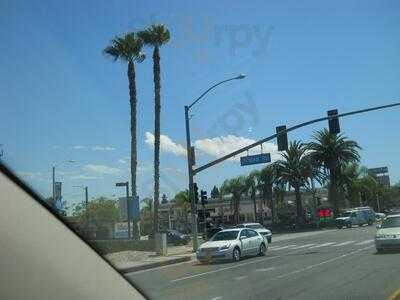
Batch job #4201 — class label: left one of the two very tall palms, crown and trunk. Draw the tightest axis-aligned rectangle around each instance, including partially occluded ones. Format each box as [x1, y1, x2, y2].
[103, 32, 145, 238]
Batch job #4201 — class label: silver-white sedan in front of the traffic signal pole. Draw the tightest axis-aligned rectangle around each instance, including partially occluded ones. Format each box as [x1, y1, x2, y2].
[196, 228, 268, 262]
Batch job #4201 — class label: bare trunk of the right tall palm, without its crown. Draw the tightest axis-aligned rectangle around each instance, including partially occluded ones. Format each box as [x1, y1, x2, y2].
[153, 46, 161, 233]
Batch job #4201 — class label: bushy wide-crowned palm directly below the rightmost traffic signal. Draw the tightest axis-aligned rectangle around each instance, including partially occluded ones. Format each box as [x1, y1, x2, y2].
[307, 128, 361, 215]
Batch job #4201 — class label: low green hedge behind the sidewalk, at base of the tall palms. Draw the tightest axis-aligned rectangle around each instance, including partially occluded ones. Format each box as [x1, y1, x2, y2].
[89, 240, 154, 254]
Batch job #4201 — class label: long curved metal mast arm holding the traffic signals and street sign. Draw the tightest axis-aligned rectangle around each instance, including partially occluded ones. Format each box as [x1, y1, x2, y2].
[193, 102, 400, 175]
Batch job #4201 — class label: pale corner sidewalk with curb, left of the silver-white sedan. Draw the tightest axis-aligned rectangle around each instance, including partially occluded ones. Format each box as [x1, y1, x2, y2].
[104, 244, 194, 273]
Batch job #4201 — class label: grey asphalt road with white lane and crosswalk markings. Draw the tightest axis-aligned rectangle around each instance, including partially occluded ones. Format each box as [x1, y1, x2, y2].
[126, 226, 400, 300]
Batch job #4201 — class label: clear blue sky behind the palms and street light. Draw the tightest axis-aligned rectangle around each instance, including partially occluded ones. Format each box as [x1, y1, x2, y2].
[0, 1, 400, 211]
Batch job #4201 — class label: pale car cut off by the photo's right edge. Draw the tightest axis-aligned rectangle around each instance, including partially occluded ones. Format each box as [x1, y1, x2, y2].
[375, 214, 400, 253]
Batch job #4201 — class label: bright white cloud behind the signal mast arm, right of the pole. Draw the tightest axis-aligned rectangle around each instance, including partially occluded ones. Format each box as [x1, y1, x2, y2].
[194, 135, 279, 161]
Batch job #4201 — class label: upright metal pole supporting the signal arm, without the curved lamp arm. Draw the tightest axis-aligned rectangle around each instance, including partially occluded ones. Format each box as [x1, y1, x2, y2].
[185, 105, 198, 251]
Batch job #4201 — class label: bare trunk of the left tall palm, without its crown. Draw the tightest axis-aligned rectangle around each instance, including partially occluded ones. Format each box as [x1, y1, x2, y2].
[128, 61, 139, 239]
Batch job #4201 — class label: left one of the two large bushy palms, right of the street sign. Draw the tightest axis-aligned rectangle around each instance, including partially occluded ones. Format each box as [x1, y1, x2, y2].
[277, 141, 309, 224]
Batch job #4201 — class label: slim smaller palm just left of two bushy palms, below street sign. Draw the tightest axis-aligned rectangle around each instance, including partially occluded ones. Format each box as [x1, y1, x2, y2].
[258, 164, 276, 223]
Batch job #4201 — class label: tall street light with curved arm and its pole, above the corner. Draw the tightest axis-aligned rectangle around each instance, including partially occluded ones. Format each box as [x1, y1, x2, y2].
[185, 74, 246, 251]
